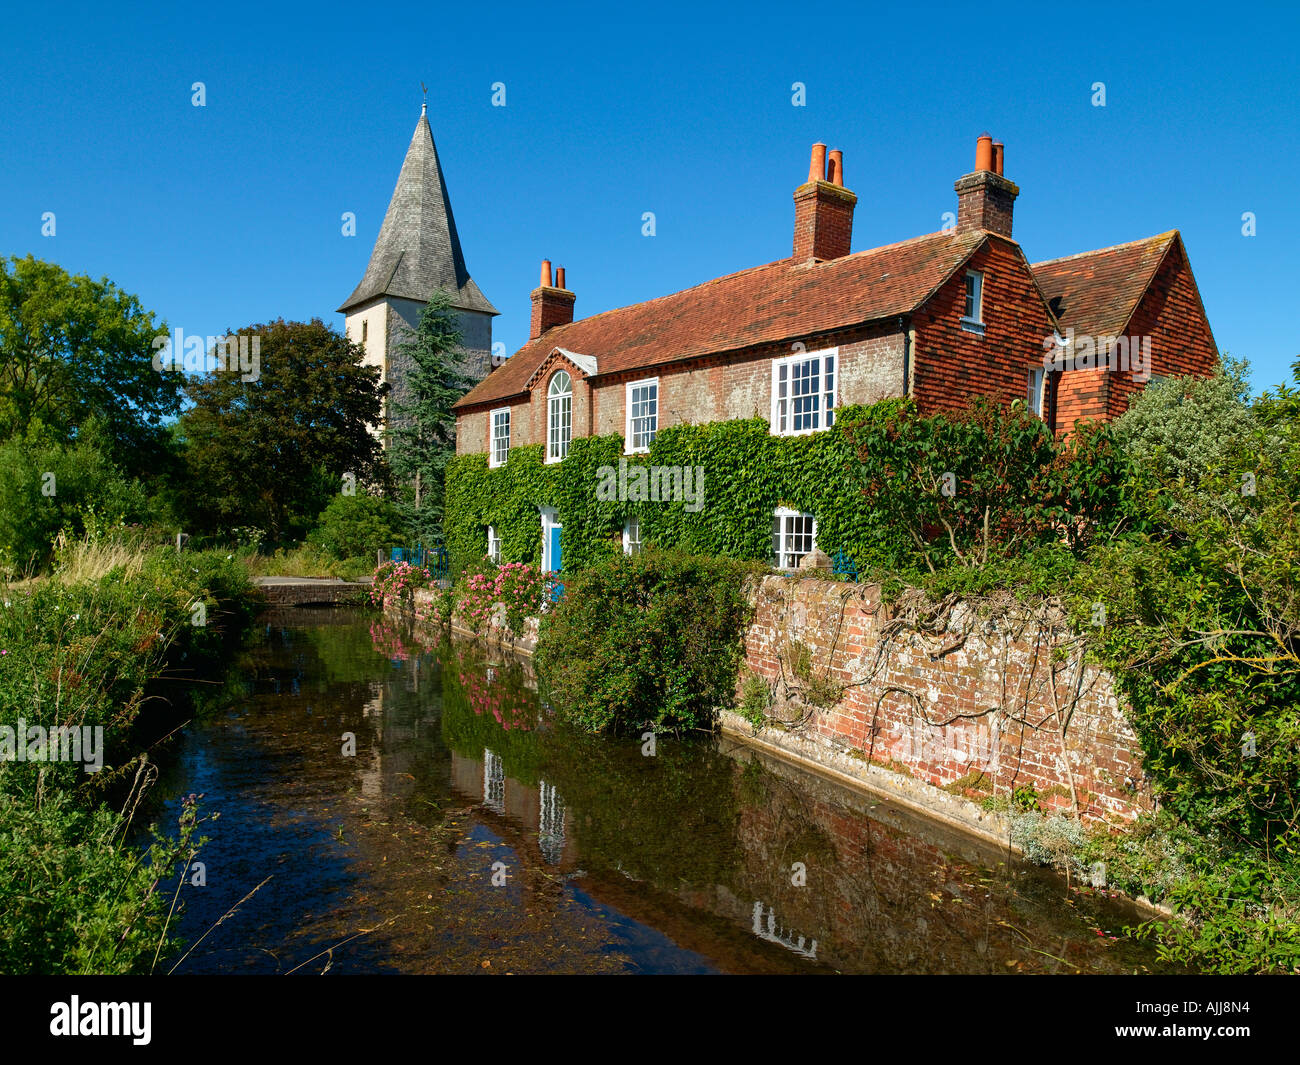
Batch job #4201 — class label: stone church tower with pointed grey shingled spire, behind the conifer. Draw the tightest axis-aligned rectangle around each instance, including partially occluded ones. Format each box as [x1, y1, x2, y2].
[338, 105, 499, 436]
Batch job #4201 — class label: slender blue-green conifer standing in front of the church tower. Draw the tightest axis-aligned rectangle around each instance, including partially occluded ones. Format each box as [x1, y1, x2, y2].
[389, 291, 475, 544]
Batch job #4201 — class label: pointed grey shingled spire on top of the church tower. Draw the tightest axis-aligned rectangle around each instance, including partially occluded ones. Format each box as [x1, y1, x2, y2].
[338, 111, 498, 315]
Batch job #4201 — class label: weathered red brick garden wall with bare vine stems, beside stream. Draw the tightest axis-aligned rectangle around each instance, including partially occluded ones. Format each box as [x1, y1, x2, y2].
[740, 576, 1151, 822]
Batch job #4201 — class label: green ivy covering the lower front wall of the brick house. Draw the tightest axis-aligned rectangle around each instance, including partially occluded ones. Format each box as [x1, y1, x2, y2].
[445, 401, 906, 572]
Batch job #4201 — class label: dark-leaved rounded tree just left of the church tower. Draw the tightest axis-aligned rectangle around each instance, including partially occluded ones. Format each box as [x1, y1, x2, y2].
[181, 319, 387, 541]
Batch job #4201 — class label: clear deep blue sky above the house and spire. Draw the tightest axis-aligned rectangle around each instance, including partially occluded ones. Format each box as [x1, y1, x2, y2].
[0, 3, 1300, 389]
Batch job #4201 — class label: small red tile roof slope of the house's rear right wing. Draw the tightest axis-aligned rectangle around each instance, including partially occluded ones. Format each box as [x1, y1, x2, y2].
[1030, 229, 1179, 337]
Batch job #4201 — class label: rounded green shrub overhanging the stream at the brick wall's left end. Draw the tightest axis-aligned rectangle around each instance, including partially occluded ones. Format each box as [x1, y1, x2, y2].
[537, 549, 755, 732]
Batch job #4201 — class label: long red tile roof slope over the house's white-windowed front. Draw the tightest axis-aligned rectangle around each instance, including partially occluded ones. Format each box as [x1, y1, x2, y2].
[456, 230, 987, 407]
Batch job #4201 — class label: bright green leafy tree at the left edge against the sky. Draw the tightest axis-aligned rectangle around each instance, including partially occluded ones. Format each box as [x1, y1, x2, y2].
[0, 255, 181, 476]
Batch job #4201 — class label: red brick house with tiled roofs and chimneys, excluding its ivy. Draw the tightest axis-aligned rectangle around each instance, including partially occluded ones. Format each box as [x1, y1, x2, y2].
[456, 134, 1218, 568]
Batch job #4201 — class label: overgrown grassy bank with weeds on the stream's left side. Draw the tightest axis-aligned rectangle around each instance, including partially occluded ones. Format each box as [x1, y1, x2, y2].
[0, 540, 254, 974]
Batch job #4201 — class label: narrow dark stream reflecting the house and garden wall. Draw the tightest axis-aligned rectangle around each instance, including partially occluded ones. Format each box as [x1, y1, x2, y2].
[156, 610, 1158, 973]
